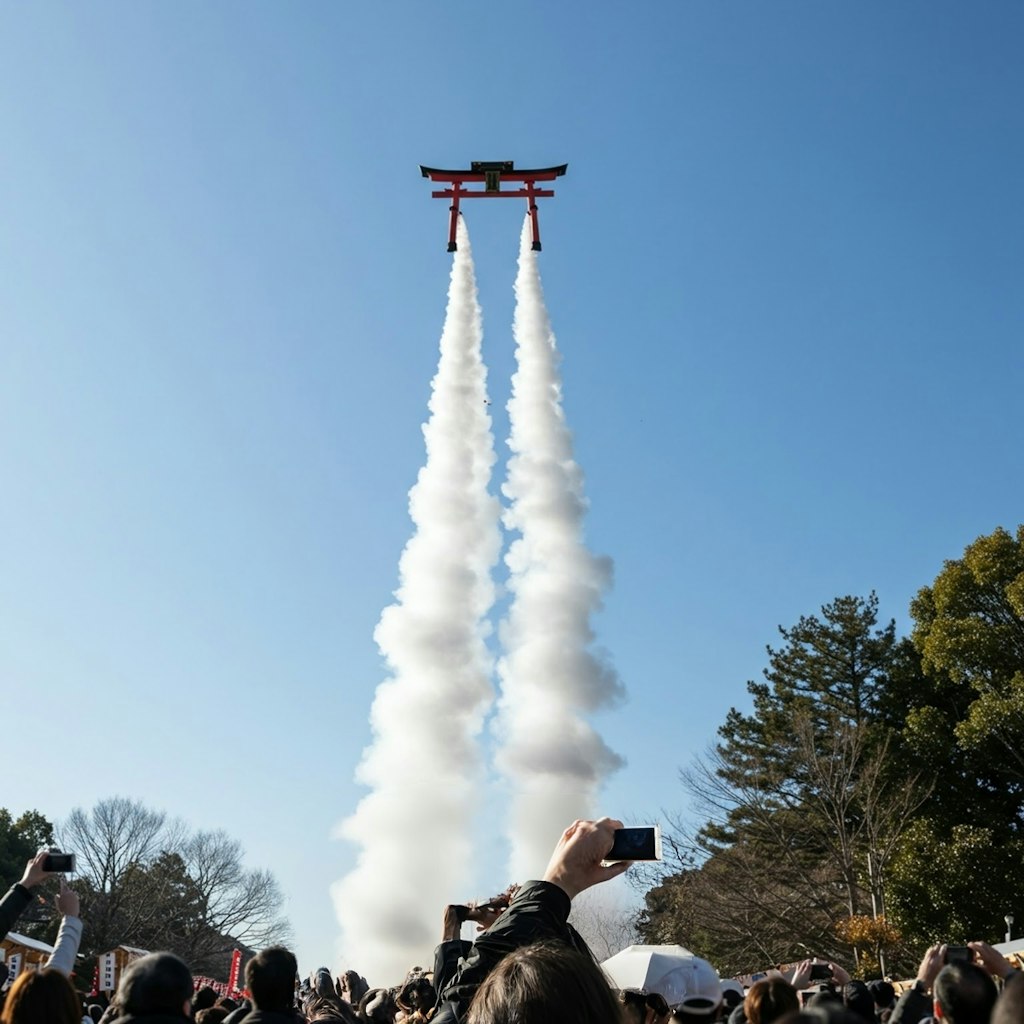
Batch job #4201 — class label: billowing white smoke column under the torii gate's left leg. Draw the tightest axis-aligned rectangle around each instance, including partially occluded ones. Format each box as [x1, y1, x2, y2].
[332, 221, 501, 986]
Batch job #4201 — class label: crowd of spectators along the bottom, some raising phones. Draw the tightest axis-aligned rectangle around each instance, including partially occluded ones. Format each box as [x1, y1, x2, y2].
[0, 818, 1024, 1024]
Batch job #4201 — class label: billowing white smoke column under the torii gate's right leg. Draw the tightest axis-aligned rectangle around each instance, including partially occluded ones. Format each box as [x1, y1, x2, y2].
[495, 218, 624, 880]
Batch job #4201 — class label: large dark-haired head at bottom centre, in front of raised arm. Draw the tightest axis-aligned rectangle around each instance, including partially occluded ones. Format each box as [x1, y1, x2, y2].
[466, 941, 622, 1024]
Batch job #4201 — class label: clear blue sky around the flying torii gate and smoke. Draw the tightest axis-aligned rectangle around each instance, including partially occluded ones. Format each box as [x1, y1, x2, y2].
[0, 0, 1024, 967]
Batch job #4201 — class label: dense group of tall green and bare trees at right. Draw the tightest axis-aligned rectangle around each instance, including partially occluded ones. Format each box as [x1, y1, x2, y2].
[639, 526, 1024, 974]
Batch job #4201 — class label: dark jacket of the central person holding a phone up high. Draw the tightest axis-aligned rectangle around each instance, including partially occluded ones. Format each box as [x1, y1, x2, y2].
[432, 882, 593, 1024]
